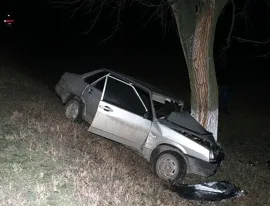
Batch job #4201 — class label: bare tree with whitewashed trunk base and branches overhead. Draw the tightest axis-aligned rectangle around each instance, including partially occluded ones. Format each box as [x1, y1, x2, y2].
[51, 0, 231, 140]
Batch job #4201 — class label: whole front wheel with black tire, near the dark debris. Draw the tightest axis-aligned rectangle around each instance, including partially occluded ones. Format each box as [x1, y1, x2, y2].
[151, 151, 187, 184]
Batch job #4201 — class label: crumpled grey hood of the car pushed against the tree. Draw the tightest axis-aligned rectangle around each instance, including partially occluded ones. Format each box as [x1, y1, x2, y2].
[160, 111, 215, 143]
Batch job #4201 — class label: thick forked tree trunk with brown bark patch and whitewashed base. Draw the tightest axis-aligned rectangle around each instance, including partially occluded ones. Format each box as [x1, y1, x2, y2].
[172, 0, 227, 141]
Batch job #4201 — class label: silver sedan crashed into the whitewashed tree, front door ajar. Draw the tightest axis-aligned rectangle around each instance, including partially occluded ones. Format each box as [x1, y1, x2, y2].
[55, 69, 224, 183]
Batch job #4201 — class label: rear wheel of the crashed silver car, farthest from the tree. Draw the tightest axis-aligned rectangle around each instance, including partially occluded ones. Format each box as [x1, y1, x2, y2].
[65, 99, 82, 122]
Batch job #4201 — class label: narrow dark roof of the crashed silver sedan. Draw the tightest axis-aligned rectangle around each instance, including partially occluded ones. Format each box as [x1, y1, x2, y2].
[95, 68, 183, 102]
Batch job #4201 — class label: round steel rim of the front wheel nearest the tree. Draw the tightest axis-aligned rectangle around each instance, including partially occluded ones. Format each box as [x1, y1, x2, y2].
[156, 154, 179, 180]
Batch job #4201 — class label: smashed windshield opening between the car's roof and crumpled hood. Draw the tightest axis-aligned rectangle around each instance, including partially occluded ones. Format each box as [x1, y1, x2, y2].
[153, 95, 183, 119]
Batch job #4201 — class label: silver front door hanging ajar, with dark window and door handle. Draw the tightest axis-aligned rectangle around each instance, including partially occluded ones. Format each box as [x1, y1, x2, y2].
[89, 76, 152, 150]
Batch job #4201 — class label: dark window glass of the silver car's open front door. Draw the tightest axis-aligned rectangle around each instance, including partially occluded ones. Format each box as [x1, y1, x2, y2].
[103, 77, 145, 116]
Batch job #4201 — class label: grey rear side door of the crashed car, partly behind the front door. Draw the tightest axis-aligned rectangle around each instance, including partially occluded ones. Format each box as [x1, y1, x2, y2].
[82, 73, 106, 124]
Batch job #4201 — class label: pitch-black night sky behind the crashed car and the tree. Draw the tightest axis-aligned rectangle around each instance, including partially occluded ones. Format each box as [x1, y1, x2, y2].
[0, 0, 270, 100]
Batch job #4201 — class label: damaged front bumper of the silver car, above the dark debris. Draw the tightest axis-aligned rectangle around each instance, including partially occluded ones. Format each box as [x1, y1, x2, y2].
[187, 152, 224, 177]
